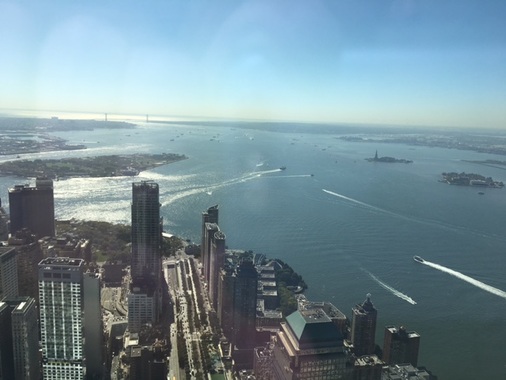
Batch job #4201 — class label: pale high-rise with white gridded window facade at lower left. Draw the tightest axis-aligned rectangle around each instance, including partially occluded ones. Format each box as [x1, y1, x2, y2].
[39, 257, 85, 380]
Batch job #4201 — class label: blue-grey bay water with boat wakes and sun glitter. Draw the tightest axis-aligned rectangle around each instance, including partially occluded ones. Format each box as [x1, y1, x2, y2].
[0, 123, 506, 380]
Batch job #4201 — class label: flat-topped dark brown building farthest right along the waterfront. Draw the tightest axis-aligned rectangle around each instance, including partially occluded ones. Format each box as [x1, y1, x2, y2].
[383, 326, 420, 367]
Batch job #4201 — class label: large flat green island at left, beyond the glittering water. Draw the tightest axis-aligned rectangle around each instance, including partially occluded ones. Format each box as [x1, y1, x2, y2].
[0, 153, 187, 180]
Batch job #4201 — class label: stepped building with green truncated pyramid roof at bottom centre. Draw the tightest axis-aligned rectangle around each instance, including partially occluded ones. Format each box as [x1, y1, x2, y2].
[270, 308, 350, 380]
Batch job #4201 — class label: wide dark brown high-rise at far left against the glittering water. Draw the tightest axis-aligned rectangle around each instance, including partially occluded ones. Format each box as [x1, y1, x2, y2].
[9, 177, 55, 237]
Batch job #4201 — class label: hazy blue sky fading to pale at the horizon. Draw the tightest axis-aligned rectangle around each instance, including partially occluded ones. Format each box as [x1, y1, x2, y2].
[0, 0, 506, 128]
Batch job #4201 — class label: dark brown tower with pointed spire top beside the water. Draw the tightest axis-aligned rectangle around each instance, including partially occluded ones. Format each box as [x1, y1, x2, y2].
[351, 294, 378, 356]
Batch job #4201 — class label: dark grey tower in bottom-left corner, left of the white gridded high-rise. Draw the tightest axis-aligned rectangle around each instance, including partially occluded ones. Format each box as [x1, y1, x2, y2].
[0, 297, 40, 380]
